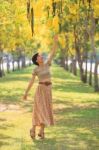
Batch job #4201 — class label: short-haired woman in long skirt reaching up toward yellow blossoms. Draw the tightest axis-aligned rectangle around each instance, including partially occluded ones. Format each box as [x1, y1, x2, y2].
[23, 35, 58, 139]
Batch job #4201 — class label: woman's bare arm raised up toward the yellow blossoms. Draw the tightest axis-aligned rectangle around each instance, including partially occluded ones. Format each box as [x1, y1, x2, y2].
[47, 35, 58, 64]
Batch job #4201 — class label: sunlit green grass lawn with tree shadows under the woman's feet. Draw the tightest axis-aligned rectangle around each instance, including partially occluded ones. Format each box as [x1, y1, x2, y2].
[0, 65, 99, 150]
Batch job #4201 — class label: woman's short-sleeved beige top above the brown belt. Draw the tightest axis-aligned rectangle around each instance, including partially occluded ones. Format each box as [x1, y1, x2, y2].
[32, 61, 51, 81]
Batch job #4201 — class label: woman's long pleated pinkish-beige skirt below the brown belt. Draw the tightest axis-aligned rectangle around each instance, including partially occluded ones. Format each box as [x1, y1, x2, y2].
[32, 84, 54, 126]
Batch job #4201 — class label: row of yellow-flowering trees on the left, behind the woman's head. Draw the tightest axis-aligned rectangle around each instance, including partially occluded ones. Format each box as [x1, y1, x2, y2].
[0, 0, 39, 77]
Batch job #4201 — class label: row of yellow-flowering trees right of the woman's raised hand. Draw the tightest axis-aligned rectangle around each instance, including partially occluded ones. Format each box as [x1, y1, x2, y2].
[56, 0, 99, 91]
